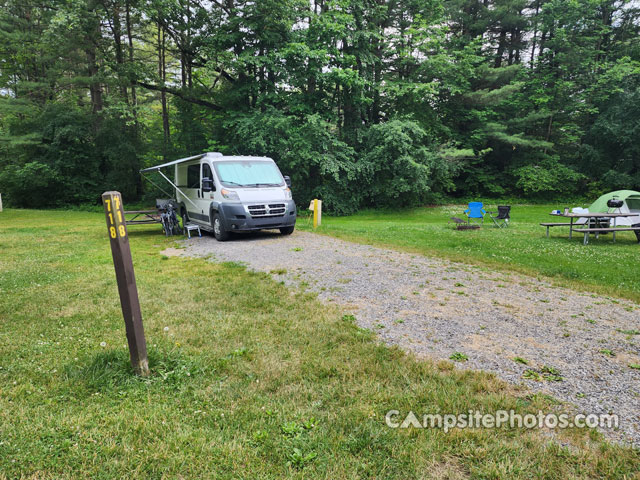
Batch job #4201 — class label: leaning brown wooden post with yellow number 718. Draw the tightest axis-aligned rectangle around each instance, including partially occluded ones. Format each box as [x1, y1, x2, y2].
[102, 192, 149, 377]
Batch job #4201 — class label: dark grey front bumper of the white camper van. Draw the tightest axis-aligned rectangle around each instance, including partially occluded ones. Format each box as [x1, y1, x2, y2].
[218, 200, 296, 232]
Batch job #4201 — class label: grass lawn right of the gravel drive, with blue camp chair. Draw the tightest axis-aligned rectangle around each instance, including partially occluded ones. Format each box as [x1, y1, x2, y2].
[298, 205, 640, 302]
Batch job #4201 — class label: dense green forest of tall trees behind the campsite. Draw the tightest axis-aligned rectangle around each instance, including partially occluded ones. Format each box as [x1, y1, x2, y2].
[0, 0, 640, 213]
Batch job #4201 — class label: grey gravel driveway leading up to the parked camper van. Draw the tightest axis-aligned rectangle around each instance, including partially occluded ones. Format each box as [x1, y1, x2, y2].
[166, 232, 640, 446]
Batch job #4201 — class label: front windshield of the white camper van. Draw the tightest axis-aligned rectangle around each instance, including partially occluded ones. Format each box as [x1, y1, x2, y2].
[214, 160, 284, 187]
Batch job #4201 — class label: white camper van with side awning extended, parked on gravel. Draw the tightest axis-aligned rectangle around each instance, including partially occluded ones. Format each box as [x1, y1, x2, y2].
[141, 152, 296, 241]
